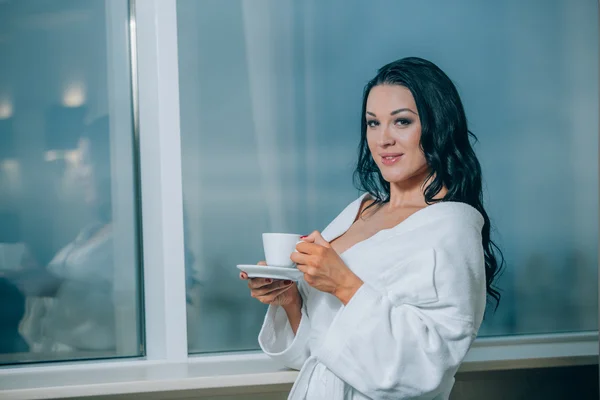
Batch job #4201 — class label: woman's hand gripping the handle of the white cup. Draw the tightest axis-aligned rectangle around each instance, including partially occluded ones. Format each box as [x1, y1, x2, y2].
[290, 231, 363, 305]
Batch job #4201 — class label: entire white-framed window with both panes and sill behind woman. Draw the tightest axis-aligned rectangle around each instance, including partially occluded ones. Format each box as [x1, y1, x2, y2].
[0, 0, 598, 398]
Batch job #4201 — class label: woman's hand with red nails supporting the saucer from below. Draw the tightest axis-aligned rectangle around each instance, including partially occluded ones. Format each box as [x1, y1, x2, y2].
[240, 261, 302, 306]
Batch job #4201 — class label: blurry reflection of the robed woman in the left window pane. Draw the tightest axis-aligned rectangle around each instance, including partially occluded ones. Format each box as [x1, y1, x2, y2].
[13, 117, 116, 352]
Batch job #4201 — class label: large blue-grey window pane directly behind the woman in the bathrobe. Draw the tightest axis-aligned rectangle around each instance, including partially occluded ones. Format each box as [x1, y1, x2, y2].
[177, 0, 598, 352]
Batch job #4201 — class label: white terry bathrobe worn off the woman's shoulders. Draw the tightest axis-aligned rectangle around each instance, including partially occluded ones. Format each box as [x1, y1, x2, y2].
[259, 194, 486, 400]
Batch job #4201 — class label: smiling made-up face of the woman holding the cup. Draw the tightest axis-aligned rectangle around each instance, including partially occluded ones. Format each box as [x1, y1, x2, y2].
[366, 85, 429, 183]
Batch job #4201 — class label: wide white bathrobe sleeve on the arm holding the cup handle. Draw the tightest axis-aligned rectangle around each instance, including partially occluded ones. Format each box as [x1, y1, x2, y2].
[315, 247, 485, 400]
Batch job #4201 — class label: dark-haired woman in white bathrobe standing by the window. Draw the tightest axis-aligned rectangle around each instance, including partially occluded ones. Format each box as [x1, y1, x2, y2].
[241, 58, 502, 399]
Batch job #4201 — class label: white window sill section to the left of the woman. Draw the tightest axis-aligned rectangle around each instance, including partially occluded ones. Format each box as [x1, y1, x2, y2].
[0, 353, 298, 400]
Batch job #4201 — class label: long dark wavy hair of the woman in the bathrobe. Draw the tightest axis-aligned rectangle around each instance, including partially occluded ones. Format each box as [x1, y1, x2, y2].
[354, 57, 504, 309]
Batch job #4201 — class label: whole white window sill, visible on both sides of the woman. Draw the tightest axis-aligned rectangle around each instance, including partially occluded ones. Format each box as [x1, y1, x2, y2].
[0, 332, 598, 399]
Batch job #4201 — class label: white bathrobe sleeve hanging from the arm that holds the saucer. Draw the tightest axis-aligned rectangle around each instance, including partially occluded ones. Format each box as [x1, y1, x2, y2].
[258, 281, 311, 370]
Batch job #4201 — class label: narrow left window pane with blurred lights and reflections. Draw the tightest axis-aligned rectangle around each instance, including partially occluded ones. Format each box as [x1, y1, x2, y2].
[0, 0, 143, 364]
